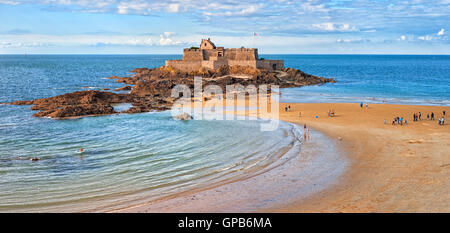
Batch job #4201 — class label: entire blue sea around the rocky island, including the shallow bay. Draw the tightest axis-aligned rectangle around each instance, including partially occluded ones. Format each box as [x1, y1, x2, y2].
[0, 55, 450, 212]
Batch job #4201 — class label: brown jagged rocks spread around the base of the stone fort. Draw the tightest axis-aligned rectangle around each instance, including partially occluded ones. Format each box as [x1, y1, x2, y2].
[10, 66, 334, 118]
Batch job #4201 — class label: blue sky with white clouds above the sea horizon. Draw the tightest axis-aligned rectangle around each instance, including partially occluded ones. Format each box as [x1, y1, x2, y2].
[0, 0, 450, 54]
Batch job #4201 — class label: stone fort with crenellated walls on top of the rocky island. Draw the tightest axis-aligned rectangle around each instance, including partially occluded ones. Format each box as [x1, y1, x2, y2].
[166, 38, 284, 71]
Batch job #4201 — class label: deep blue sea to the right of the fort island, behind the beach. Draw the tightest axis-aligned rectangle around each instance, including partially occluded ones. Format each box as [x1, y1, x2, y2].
[264, 55, 450, 106]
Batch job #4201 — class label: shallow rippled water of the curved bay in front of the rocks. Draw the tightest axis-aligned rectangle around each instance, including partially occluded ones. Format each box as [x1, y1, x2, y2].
[0, 106, 302, 211]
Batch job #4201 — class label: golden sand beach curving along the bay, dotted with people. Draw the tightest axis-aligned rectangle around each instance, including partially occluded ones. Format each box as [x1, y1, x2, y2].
[115, 103, 450, 212]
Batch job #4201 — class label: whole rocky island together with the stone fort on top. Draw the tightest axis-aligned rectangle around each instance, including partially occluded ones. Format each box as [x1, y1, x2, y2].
[9, 39, 334, 119]
